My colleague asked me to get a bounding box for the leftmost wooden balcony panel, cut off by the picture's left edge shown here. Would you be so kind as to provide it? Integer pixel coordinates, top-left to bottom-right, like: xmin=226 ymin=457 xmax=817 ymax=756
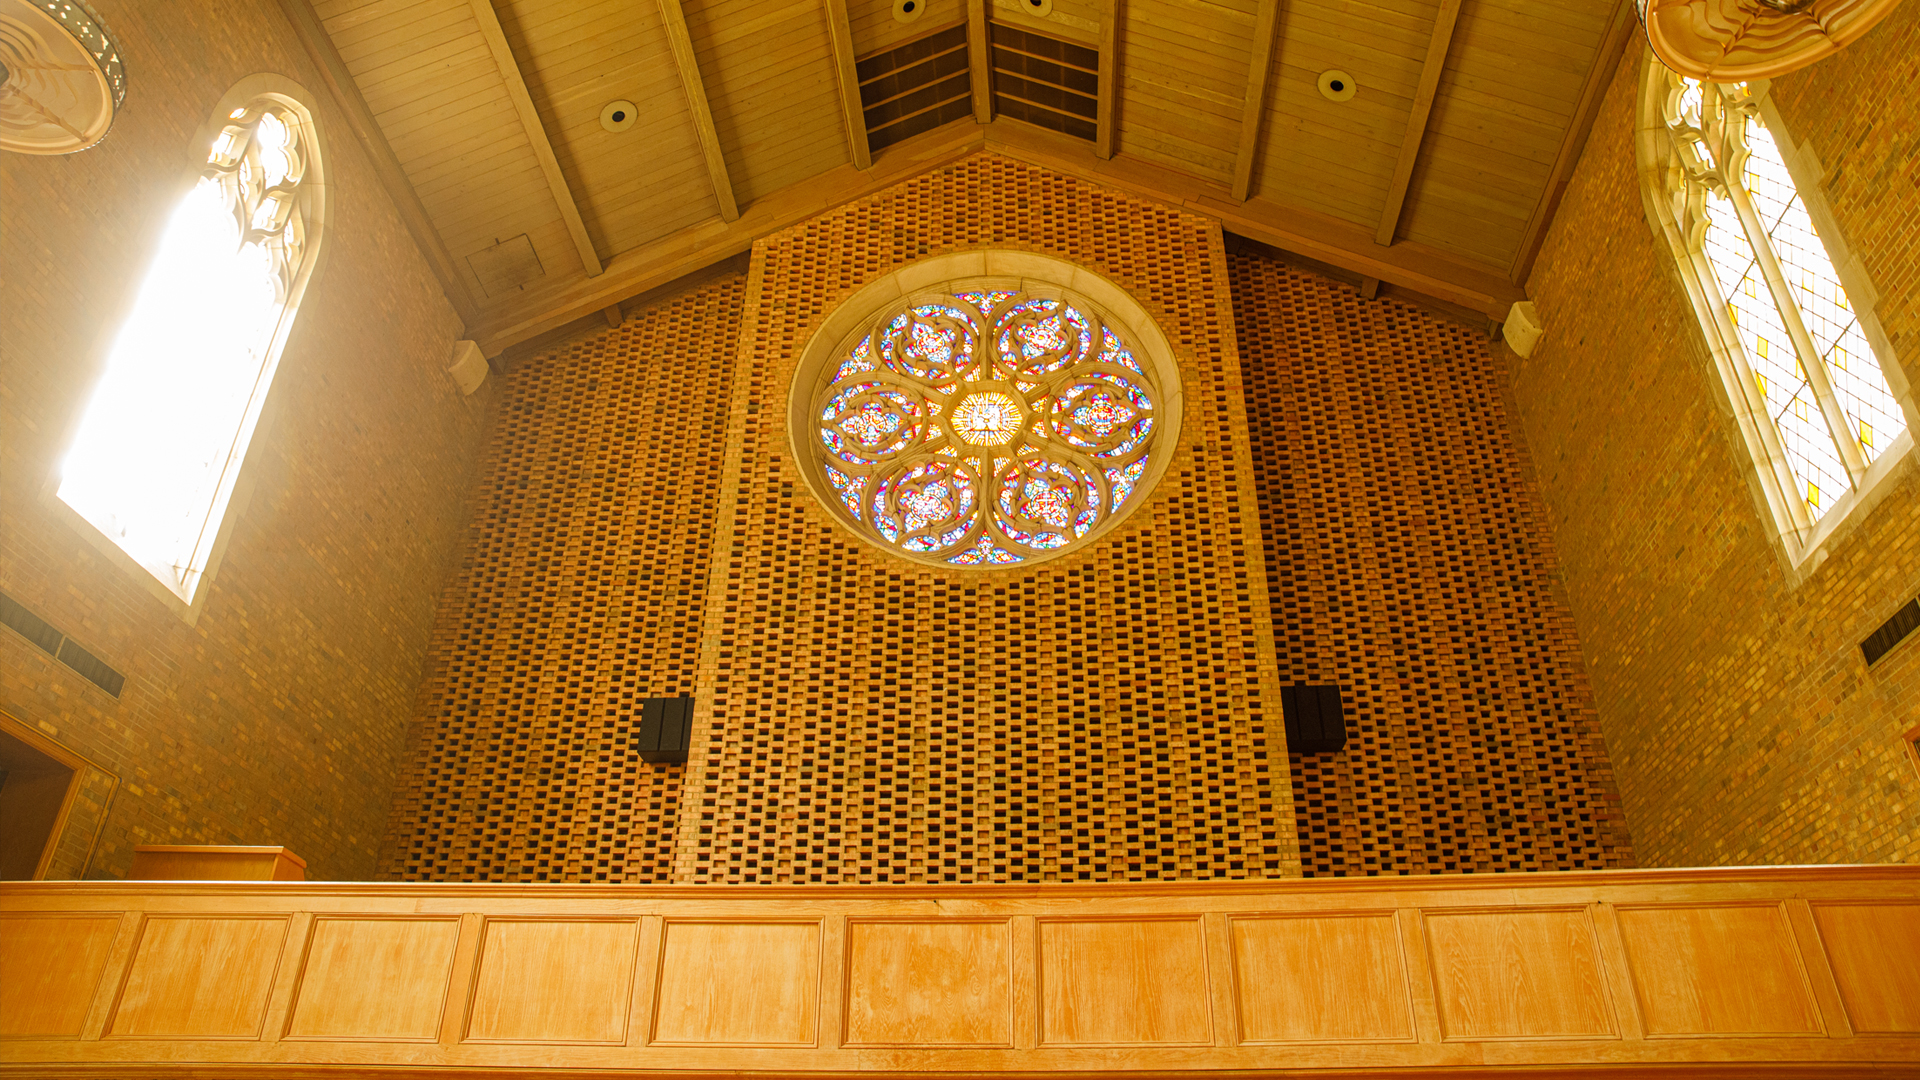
xmin=0 ymin=915 xmax=121 ymax=1038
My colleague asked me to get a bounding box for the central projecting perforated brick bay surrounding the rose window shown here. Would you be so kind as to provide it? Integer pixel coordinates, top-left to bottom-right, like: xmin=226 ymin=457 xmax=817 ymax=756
xmin=676 ymin=154 xmax=1298 ymax=882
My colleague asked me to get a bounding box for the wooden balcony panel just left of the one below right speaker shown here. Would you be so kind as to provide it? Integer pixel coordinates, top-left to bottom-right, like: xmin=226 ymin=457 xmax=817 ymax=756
xmin=1039 ymin=919 xmax=1213 ymax=1045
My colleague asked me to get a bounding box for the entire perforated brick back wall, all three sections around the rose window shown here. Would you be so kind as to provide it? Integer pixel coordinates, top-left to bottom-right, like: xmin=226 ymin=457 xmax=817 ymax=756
xmin=382 ymin=156 xmax=1634 ymax=882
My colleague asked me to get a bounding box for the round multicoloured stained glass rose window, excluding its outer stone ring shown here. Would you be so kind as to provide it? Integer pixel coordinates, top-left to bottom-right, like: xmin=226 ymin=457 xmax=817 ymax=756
xmin=810 ymin=288 xmax=1164 ymax=567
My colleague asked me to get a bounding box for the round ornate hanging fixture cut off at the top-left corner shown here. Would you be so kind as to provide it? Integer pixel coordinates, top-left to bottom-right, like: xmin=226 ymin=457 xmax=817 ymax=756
xmin=0 ymin=0 xmax=127 ymax=154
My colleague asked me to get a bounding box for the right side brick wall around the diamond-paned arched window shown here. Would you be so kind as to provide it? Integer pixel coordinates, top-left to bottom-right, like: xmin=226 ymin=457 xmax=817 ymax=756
xmin=1513 ymin=12 xmax=1920 ymax=865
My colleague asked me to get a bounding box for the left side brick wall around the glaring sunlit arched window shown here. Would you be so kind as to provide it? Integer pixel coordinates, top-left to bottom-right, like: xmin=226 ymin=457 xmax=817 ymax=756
xmin=0 ymin=2 xmax=486 ymax=878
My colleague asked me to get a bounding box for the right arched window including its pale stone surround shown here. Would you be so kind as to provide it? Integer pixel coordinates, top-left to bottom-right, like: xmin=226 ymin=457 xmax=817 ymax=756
xmin=1640 ymin=63 xmax=1912 ymax=563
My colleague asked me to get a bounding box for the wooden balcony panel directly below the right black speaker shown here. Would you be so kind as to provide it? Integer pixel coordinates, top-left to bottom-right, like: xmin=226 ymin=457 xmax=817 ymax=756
xmin=1231 ymin=911 xmax=1413 ymax=1043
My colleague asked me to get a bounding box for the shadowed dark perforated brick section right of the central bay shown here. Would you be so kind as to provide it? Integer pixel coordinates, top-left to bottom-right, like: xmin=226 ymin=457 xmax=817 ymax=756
xmin=1231 ymin=252 xmax=1634 ymax=876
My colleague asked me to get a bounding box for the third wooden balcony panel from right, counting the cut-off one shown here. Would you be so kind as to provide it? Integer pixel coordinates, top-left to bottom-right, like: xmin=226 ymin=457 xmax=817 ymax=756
xmin=1427 ymin=909 xmax=1619 ymax=1040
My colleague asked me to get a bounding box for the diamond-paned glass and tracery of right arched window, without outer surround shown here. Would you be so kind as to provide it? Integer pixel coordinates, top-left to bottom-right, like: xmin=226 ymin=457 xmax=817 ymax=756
xmin=1655 ymin=71 xmax=1907 ymax=528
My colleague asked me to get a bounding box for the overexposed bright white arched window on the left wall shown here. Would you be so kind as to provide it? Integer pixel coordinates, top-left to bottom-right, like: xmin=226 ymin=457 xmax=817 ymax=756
xmin=58 ymin=77 xmax=324 ymax=605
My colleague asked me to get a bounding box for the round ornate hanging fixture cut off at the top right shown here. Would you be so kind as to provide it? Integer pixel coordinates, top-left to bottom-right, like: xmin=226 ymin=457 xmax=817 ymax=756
xmin=1634 ymin=0 xmax=1899 ymax=83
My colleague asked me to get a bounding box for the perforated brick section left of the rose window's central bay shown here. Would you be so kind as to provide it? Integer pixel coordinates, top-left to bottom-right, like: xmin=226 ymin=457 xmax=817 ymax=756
xmin=382 ymin=277 xmax=747 ymax=882
